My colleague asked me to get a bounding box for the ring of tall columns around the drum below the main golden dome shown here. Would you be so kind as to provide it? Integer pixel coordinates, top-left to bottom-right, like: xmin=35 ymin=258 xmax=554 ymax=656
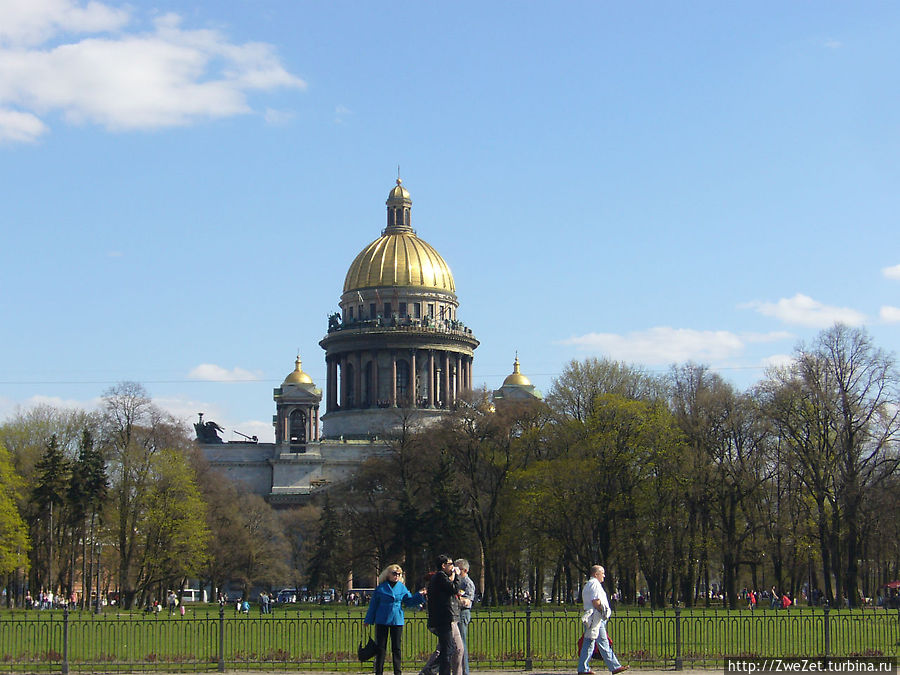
xmin=326 ymin=349 xmax=473 ymax=413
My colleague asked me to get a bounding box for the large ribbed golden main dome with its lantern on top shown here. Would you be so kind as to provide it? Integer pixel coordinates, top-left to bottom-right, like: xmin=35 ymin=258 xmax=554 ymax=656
xmin=344 ymin=178 xmax=456 ymax=293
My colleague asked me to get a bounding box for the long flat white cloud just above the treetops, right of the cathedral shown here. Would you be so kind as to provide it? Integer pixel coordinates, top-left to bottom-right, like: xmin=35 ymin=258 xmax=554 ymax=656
xmin=562 ymin=326 xmax=745 ymax=365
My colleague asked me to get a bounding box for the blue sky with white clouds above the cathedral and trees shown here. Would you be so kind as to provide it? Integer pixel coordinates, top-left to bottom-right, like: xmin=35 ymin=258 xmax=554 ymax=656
xmin=0 ymin=0 xmax=900 ymax=440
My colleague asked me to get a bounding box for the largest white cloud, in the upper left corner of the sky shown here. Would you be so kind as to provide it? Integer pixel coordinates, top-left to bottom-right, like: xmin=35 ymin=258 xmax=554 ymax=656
xmin=0 ymin=0 xmax=306 ymax=140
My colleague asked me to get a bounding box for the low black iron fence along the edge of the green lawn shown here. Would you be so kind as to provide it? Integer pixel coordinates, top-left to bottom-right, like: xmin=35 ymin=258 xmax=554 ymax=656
xmin=0 ymin=607 xmax=900 ymax=675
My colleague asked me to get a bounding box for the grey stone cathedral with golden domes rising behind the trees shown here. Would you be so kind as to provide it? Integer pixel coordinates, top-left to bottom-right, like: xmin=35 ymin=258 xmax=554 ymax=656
xmin=202 ymin=178 xmax=541 ymax=505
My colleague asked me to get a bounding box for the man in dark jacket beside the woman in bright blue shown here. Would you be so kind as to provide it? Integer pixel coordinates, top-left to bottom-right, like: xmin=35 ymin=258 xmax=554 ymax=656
xmin=426 ymin=555 xmax=462 ymax=675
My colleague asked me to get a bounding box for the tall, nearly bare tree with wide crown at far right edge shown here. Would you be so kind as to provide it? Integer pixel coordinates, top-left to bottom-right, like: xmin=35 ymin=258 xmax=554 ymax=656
xmin=762 ymin=324 xmax=900 ymax=606
